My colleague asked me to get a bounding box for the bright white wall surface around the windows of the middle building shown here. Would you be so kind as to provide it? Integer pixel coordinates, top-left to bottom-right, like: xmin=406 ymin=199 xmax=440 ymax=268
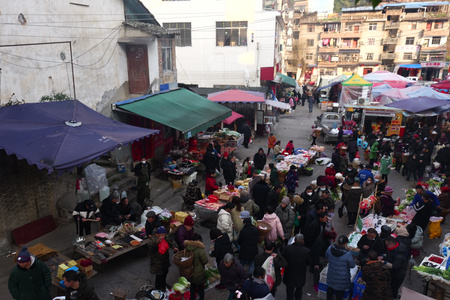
xmin=142 ymin=0 xmax=280 ymax=87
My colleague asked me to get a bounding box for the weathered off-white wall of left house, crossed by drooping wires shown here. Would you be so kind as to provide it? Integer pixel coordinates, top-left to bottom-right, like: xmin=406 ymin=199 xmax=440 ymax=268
xmin=0 ymin=0 xmax=158 ymax=111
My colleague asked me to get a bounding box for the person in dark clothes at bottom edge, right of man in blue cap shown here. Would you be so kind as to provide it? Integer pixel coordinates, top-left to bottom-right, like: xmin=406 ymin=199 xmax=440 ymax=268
xmin=63 ymin=270 xmax=100 ymax=300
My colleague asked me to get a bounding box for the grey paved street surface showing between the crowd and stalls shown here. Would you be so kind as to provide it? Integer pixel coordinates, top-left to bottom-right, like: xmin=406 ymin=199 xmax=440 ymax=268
xmin=0 ymin=102 xmax=449 ymax=300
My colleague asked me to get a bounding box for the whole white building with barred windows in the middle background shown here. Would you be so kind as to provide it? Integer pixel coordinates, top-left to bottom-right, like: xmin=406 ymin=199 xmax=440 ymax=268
xmin=143 ymin=0 xmax=284 ymax=87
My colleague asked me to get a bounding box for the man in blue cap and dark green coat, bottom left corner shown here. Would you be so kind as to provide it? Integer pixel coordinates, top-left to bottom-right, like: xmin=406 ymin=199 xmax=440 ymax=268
xmin=8 ymin=246 xmax=52 ymax=300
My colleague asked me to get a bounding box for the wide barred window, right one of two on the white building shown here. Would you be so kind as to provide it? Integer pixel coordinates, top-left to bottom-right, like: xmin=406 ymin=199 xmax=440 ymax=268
xmin=216 ymin=21 xmax=247 ymax=47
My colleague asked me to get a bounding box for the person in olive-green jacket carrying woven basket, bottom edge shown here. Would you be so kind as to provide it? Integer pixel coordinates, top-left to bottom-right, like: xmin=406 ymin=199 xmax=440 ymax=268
xmin=184 ymin=233 xmax=208 ymax=300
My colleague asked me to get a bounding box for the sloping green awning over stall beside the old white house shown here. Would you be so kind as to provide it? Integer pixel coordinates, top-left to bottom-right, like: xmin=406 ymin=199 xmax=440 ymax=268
xmin=115 ymin=89 xmax=231 ymax=138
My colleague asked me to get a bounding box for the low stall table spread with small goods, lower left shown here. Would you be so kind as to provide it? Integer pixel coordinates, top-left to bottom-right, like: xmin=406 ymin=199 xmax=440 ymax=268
xmin=74 ymin=233 xmax=149 ymax=266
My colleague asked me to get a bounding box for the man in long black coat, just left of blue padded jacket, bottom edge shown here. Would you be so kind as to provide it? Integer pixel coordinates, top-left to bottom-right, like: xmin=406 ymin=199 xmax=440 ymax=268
xmin=283 ymin=233 xmax=311 ymax=300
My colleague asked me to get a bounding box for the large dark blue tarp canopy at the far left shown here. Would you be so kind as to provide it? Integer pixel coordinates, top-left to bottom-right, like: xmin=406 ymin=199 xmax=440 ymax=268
xmin=0 ymin=100 xmax=158 ymax=173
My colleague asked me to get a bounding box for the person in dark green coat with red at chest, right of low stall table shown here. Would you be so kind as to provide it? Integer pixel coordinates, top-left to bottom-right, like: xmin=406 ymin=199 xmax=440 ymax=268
xmin=148 ymin=226 xmax=178 ymax=292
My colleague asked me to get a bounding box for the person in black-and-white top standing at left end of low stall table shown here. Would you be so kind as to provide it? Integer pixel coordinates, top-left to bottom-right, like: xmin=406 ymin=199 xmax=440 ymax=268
xmin=72 ymin=199 xmax=100 ymax=236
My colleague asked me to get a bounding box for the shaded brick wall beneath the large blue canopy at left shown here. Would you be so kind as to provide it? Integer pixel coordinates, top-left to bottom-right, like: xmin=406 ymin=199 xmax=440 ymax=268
xmin=0 ymin=150 xmax=76 ymax=242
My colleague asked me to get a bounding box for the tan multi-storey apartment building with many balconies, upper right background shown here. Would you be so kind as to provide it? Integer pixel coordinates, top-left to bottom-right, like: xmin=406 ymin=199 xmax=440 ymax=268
xmin=286 ymin=2 xmax=450 ymax=81
